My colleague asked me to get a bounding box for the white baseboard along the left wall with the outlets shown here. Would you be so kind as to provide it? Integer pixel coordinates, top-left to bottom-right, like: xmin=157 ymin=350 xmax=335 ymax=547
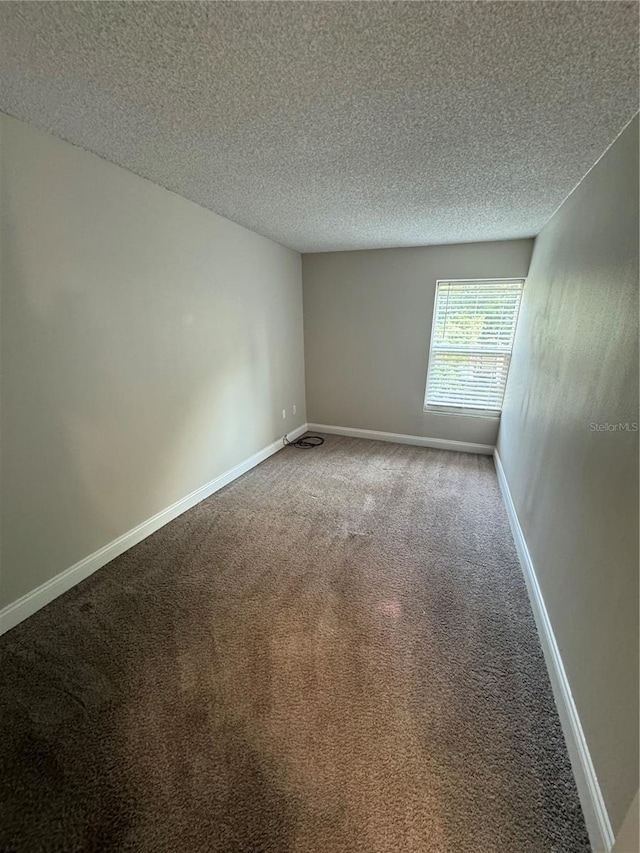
xmin=0 ymin=424 xmax=307 ymax=634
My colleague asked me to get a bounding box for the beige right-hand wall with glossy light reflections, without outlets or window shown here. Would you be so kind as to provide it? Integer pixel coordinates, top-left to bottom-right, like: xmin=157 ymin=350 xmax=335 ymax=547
xmin=498 ymin=119 xmax=639 ymax=832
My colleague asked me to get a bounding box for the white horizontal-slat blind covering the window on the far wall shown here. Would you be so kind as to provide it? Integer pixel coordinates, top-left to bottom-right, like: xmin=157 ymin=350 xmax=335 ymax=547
xmin=425 ymin=280 xmax=524 ymax=412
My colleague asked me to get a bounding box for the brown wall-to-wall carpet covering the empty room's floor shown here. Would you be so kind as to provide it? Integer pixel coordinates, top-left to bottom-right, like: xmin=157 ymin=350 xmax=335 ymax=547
xmin=0 ymin=436 xmax=589 ymax=853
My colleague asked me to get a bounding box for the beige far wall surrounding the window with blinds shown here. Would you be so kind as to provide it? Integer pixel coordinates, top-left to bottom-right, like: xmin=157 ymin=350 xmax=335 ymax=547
xmin=302 ymin=240 xmax=533 ymax=445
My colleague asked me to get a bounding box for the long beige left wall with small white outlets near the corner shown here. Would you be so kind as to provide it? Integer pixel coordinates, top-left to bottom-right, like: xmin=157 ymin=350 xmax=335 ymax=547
xmin=0 ymin=117 xmax=306 ymax=605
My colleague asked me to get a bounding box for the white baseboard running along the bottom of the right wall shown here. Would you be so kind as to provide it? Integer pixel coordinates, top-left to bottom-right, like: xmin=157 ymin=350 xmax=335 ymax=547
xmin=494 ymin=449 xmax=614 ymax=853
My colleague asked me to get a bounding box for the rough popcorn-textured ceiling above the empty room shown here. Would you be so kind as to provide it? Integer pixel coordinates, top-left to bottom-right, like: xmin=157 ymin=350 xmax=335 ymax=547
xmin=0 ymin=0 xmax=638 ymax=252
